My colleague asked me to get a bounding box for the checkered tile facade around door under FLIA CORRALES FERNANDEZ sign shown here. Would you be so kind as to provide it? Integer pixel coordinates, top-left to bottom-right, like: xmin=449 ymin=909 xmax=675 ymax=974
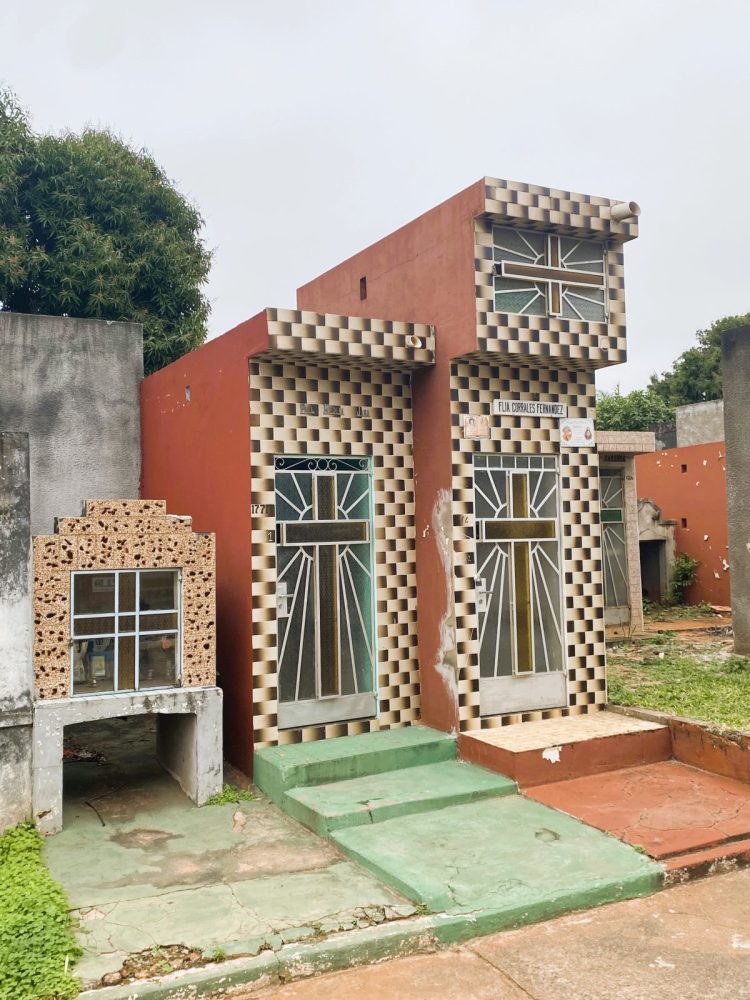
xmin=451 ymin=359 xmax=606 ymax=731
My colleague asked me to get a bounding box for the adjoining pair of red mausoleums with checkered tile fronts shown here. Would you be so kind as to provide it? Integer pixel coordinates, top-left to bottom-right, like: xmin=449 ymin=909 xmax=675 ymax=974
xmin=142 ymin=178 xmax=638 ymax=772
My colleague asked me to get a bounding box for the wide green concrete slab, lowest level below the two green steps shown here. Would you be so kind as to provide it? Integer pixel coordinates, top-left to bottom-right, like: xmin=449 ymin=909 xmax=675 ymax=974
xmin=331 ymin=795 xmax=662 ymax=934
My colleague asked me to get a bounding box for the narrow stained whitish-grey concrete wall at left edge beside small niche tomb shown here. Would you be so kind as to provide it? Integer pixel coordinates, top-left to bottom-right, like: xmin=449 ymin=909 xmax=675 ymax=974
xmin=0 ymin=433 xmax=33 ymax=831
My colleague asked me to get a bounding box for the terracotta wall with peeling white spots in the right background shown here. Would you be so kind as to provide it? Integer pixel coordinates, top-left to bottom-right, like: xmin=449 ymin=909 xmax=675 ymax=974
xmin=635 ymin=441 xmax=730 ymax=606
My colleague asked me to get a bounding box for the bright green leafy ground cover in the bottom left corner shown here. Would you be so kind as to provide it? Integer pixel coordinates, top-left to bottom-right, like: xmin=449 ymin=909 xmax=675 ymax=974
xmin=0 ymin=822 xmax=81 ymax=1000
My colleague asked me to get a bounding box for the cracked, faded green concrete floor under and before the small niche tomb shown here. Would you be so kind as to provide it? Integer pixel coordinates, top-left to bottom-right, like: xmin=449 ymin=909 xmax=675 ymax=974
xmin=44 ymin=719 xmax=415 ymax=984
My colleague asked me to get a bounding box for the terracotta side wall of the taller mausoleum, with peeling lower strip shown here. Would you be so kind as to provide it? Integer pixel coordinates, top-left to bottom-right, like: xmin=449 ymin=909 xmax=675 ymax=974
xmin=297 ymin=179 xmax=485 ymax=731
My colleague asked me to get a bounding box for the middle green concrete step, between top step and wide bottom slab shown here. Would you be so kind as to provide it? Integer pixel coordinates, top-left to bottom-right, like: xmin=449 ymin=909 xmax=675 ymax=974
xmin=283 ymin=760 xmax=517 ymax=837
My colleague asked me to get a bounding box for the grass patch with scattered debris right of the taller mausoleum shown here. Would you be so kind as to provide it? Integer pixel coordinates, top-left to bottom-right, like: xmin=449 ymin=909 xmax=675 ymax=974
xmin=607 ymin=637 xmax=750 ymax=730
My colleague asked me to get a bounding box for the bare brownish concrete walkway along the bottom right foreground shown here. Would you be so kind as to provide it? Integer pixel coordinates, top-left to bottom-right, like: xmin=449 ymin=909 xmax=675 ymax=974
xmin=238 ymin=870 xmax=750 ymax=1000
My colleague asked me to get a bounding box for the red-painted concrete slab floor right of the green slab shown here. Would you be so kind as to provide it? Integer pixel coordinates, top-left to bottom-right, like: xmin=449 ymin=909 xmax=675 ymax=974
xmin=525 ymin=761 xmax=750 ymax=860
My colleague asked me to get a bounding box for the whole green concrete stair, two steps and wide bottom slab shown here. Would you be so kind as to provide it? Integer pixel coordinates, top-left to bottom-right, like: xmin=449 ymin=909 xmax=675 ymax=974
xmin=255 ymin=726 xmax=663 ymax=924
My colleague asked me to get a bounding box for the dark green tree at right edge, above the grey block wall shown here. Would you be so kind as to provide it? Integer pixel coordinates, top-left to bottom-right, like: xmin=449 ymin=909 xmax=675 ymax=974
xmin=648 ymin=313 xmax=750 ymax=406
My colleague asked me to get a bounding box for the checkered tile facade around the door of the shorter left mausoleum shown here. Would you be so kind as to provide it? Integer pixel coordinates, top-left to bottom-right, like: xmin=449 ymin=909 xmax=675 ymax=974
xmin=249 ymin=359 xmax=420 ymax=747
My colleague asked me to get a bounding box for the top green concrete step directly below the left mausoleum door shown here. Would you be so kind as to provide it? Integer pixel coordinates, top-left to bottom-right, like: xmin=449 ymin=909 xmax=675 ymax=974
xmin=253 ymin=726 xmax=456 ymax=805
